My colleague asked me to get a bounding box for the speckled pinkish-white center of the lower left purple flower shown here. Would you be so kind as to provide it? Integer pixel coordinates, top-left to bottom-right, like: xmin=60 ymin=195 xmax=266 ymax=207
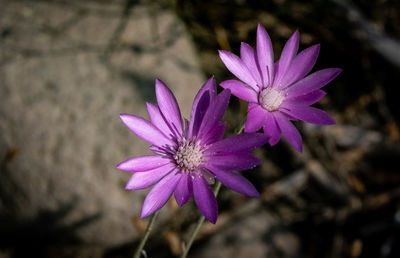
xmin=174 ymin=139 xmax=203 ymax=172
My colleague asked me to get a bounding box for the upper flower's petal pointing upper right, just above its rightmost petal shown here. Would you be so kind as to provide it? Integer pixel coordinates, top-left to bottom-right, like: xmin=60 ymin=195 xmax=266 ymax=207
xmin=280 ymin=44 xmax=320 ymax=87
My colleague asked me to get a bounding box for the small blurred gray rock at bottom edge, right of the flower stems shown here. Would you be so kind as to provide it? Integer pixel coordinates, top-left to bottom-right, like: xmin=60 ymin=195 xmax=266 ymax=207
xmin=191 ymin=210 xmax=300 ymax=258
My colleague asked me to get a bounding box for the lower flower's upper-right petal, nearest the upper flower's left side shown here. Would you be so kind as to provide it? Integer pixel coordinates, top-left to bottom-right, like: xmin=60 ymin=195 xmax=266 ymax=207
xmin=197 ymin=89 xmax=231 ymax=139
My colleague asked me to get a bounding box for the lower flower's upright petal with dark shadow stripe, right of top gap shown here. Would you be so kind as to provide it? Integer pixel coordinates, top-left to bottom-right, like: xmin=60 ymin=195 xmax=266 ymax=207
xmin=188 ymin=77 xmax=217 ymax=139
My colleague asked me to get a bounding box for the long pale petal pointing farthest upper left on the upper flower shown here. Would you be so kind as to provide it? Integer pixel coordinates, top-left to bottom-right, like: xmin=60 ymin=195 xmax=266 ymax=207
xmin=219 ymin=50 xmax=257 ymax=88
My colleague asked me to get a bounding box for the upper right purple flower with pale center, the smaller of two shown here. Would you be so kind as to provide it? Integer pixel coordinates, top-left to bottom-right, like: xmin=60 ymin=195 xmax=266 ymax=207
xmin=219 ymin=25 xmax=342 ymax=151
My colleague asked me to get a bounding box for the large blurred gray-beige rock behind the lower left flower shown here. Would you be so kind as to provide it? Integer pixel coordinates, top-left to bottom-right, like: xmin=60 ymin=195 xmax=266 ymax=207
xmin=0 ymin=1 xmax=205 ymax=250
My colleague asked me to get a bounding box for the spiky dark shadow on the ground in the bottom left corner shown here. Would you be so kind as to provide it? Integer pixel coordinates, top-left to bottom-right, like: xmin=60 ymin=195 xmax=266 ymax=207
xmin=0 ymin=202 xmax=100 ymax=258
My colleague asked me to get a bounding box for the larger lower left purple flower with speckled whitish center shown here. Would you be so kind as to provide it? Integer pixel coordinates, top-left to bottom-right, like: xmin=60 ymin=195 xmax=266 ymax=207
xmin=117 ymin=78 xmax=268 ymax=223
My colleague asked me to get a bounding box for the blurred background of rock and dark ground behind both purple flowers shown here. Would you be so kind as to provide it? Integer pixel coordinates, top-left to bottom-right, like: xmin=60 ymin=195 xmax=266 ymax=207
xmin=0 ymin=0 xmax=400 ymax=258
